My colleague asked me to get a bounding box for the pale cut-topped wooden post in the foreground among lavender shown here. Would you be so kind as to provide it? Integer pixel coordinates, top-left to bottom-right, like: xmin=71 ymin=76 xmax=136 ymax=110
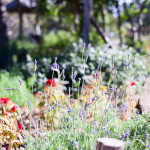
xmin=96 ymin=138 xmax=124 ymax=150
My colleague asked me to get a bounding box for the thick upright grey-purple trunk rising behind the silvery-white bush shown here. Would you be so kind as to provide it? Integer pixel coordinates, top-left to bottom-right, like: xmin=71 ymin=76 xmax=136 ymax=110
xmin=83 ymin=0 xmax=93 ymax=45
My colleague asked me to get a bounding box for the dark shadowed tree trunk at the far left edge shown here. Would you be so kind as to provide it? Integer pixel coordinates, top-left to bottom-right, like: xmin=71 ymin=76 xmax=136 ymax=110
xmin=0 ymin=0 xmax=8 ymax=45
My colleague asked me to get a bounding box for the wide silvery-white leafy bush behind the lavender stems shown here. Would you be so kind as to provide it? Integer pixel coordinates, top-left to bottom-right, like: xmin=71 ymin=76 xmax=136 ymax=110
xmin=24 ymin=41 xmax=149 ymax=89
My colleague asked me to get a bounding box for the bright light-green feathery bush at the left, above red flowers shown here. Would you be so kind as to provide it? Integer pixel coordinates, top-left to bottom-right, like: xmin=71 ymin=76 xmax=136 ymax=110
xmin=0 ymin=72 xmax=34 ymax=106
